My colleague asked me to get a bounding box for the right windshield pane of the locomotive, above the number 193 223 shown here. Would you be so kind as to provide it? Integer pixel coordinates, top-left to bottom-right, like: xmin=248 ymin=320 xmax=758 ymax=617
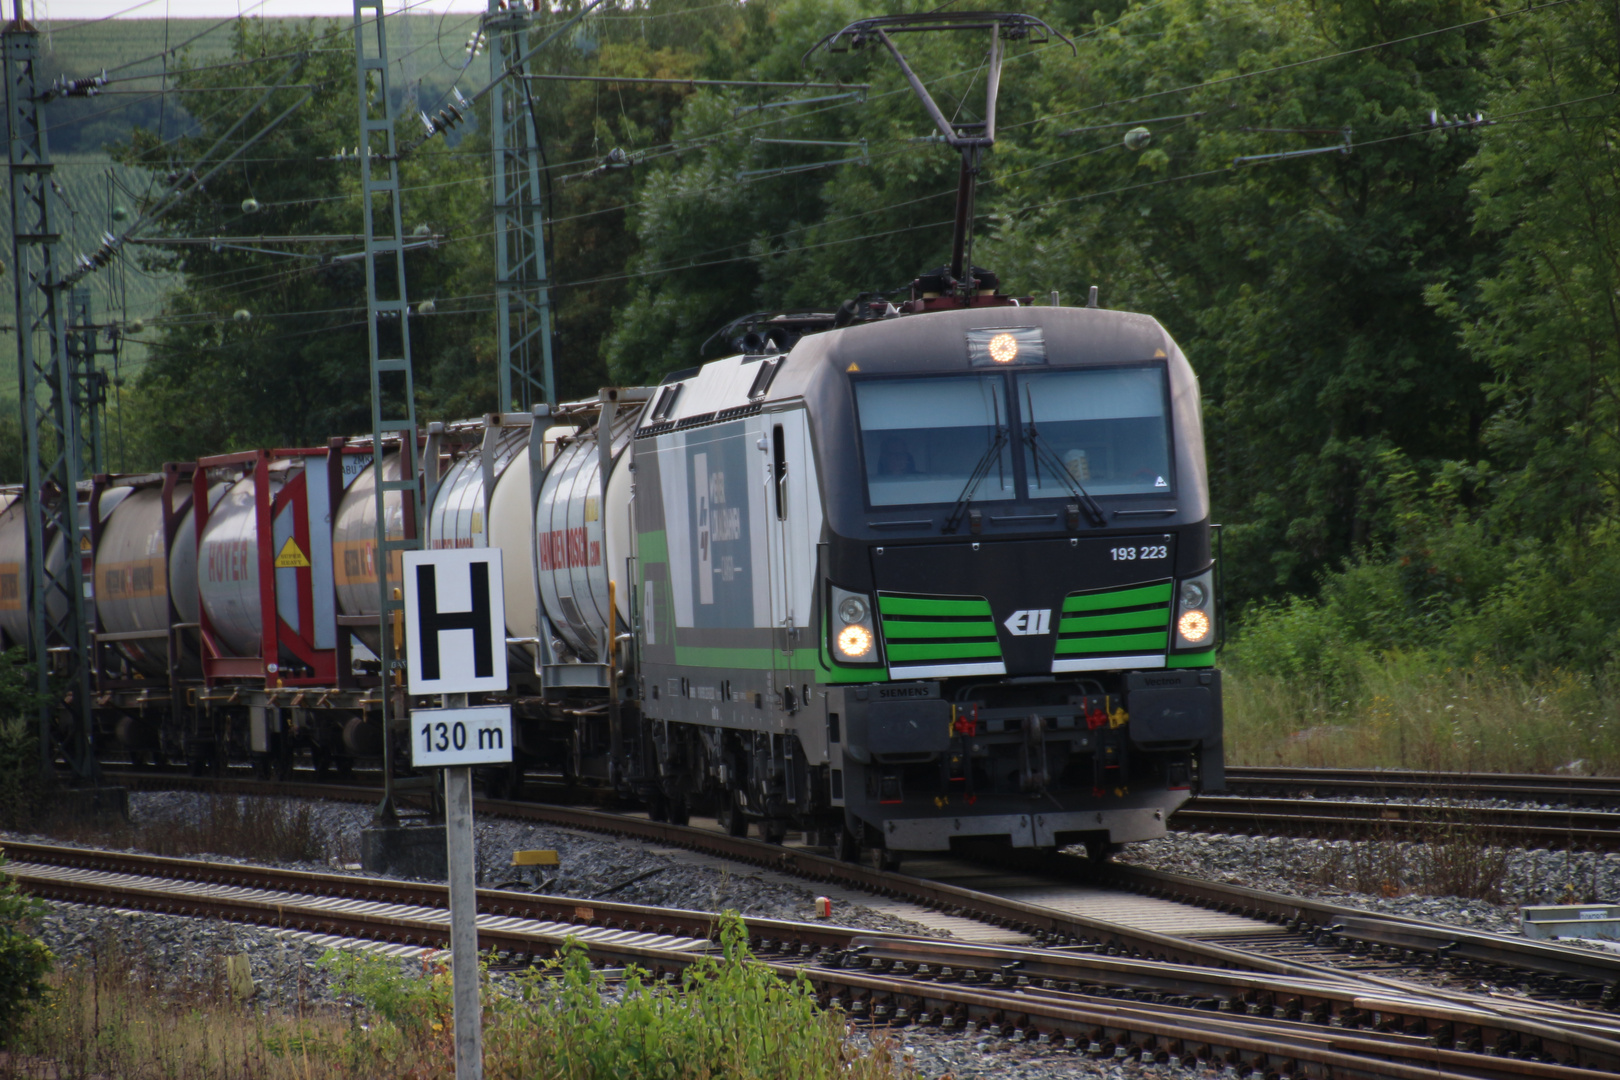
xmin=1016 ymin=366 xmax=1173 ymax=499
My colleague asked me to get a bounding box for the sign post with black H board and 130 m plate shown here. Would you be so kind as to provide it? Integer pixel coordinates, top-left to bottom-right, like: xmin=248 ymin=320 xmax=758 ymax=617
xmin=403 ymin=547 xmax=512 ymax=1080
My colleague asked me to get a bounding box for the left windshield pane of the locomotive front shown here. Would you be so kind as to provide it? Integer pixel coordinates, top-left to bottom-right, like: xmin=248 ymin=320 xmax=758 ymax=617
xmin=855 ymin=376 xmax=1016 ymax=507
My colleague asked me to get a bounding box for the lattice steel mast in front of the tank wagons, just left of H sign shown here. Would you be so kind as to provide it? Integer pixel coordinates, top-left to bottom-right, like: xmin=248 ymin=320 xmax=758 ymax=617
xmin=355 ymin=0 xmax=423 ymax=823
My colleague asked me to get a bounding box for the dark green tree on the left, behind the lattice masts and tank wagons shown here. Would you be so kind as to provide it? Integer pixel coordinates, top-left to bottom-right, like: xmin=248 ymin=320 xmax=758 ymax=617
xmin=120 ymin=19 xmax=494 ymax=465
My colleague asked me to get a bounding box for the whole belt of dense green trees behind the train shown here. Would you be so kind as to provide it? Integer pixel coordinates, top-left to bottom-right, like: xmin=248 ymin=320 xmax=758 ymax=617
xmin=41 ymin=0 xmax=1620 ymax=682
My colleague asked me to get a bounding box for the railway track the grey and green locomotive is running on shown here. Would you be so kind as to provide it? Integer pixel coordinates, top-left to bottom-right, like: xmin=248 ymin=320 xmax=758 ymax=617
xmin=98 ymin=774 xmax=1620 ymax=1009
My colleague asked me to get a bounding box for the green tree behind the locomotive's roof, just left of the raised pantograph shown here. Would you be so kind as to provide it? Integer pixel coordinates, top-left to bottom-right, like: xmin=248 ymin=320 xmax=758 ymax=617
xmin=604 ymin=0 xmax=983 ymax=382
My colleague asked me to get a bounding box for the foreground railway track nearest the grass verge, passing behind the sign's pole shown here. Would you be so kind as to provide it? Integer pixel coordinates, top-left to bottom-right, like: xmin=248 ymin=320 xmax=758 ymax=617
xmin=6 ymin=844 xmax=1620 ymax=1080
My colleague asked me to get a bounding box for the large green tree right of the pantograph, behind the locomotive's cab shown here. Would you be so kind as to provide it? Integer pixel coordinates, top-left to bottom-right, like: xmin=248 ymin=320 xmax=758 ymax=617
xmin=987 ymin=0 xmax=1494 ymax=599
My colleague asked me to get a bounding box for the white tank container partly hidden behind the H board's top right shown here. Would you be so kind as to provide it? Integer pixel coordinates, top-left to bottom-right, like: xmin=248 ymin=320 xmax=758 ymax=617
xmin=428 ymin=427 xmax=539 ymax=650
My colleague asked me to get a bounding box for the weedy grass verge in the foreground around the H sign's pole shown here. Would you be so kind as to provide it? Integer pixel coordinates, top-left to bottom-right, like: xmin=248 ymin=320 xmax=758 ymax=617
xmin=0 ymin=916 xmax=910 ymax=1080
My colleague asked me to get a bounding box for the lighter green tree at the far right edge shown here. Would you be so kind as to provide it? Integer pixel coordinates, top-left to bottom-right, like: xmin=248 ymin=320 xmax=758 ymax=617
xmin=1430 ymin=5 xmax=1620 ymax=538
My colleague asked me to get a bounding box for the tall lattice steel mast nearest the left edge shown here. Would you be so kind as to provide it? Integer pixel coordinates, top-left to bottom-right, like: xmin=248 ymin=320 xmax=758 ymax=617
xmin=0 ymin=0 xmax=97 ymax=777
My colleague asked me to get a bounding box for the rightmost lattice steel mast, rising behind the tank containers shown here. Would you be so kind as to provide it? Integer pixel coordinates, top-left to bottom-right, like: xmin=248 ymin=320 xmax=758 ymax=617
xmin=483 ymin=0 xmax=557 ymax=413
